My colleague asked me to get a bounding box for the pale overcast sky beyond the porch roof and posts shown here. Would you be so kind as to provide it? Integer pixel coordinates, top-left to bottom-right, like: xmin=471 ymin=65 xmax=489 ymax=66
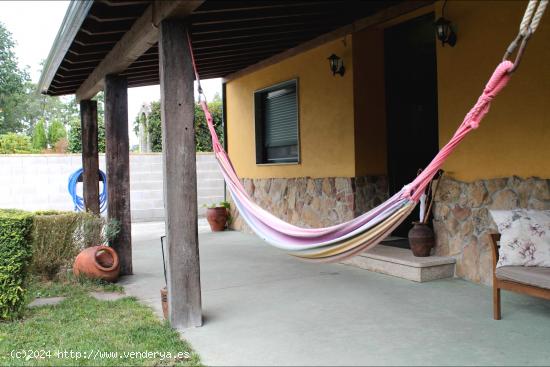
xmin=0 ymin=0 xmax=222 ymax=145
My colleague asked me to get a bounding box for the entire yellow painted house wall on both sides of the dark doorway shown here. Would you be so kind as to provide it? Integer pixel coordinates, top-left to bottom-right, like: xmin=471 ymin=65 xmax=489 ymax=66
xmin=227 ymin=1 xmax=550 ymax=181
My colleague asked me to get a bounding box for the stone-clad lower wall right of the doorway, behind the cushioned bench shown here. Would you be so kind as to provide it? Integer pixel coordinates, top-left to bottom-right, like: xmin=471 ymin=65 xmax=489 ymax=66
xmin=433 ymin=176 xmax=550 ymax=285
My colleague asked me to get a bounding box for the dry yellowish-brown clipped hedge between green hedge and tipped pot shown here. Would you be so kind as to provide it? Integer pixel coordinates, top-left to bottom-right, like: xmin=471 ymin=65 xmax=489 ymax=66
xmin=30 ymin=211 xmax=81 ymax=279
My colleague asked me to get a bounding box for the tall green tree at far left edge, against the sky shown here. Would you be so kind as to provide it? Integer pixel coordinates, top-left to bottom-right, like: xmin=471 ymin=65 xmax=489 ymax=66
xmin=0 ymin=23 xmax=30 ymax=134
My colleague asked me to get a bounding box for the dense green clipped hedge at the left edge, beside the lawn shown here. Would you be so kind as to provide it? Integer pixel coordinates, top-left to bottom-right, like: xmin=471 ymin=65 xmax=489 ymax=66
xmin=0 ymin=209 xmax=32 ymax=319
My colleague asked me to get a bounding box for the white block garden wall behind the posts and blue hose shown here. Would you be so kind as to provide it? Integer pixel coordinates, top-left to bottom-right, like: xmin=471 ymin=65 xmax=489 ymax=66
xmin=0 ymin=153 xmax=224 ymax=221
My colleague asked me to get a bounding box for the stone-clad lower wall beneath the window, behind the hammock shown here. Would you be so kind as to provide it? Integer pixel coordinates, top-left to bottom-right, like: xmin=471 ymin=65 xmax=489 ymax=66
xmin=228 ymin=176 xmax=388 ymax=233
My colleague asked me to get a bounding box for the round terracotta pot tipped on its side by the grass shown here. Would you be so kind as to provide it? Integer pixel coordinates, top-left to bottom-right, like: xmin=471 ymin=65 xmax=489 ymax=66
xmin=73 ymin=246 xmax=120 ymax=282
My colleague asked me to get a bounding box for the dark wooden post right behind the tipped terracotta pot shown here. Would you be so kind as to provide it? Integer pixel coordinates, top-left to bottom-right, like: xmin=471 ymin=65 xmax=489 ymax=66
xmin=105 ymin=75 xmax=132 ymax=275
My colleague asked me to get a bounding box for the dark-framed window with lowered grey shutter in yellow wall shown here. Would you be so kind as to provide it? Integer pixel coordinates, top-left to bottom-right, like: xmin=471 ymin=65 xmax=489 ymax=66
xmin=254 ymin=80 xmax=299 ymax=164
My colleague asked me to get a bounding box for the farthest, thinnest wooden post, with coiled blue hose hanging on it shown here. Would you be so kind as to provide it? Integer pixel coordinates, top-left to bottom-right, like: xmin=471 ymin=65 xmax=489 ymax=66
xmin=80 ymin=100 xmax=99 ymax=215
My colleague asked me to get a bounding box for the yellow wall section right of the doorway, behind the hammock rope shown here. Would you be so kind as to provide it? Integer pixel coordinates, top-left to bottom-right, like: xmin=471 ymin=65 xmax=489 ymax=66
xmin=437 ymin=1 xmax=550 ymax=181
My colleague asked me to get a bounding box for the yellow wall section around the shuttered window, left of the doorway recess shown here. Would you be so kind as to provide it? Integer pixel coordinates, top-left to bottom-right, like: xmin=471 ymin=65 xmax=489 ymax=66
xmin=226 ymin=37 xmax=355 ymax=178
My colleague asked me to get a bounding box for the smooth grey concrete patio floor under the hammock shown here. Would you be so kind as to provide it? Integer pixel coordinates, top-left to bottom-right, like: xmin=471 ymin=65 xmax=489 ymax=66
xmin=122 ymin=223 xmax=550 ymax=365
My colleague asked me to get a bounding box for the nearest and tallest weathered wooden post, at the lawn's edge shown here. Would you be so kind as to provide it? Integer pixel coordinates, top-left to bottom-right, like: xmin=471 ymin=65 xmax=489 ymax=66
xmin=159 ymin=19 xmax=202 ymax=328
